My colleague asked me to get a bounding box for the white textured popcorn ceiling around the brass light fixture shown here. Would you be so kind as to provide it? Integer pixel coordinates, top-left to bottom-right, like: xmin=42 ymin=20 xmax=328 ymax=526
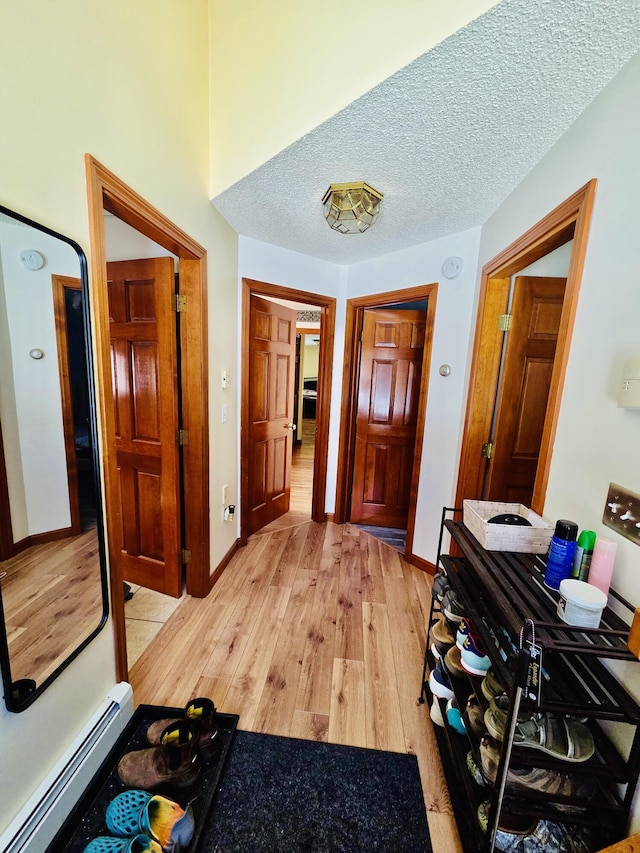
xmin=213 ymin=0 xmax=640 ymax=264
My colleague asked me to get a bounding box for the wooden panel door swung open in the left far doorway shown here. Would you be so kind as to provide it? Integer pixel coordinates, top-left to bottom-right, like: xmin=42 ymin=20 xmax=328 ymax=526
xmin=247 ymin=296 xmax=296 ymax=534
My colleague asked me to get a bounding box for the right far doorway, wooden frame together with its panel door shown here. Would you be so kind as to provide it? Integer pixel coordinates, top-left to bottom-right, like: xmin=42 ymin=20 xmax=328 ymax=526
xmin=335 ymin=284 xmax=438 ymax=562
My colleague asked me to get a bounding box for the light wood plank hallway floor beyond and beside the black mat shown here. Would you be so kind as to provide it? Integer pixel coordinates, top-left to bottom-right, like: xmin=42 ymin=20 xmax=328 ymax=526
xmin=129 ymin=519 xmax=461 ymax=853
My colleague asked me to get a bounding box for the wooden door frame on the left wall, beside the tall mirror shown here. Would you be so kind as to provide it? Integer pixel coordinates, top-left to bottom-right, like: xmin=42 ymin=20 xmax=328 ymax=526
xmin=85 ymin=154 xmax=211 ymax=680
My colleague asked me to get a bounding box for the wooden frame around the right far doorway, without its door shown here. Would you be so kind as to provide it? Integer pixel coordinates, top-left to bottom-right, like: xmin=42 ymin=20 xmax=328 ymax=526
xmin=334 ymin=283 xmax=438 ymax=562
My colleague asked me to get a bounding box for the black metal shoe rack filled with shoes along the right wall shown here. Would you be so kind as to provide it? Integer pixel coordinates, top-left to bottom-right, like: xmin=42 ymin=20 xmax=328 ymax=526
xmin=420 ymin=507 xmax=640 ymax=853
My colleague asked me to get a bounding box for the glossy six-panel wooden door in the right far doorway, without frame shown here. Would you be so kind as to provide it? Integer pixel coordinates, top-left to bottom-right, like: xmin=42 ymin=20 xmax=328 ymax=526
xmin=350 ymin=308 xmax=426 ymax=527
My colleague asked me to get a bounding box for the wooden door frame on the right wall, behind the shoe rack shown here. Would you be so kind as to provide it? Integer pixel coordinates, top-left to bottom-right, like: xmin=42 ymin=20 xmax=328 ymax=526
xmin=456 ymin=179 xmax=597 ymax=513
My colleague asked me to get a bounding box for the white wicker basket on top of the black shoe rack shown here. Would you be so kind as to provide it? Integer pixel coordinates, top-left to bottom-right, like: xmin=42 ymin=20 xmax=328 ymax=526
xmin=462 ymin=500 xmax=554 ymax=554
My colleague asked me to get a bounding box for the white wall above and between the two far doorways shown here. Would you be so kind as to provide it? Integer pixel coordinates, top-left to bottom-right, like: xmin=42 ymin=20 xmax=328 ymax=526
xmin=239 ymin=228 xmax=480 ymax=562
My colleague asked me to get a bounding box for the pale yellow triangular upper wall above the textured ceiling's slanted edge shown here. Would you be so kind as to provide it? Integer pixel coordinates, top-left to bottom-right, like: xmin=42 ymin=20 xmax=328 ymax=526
xmin=210 ymin=0 xmax=499 ymax=196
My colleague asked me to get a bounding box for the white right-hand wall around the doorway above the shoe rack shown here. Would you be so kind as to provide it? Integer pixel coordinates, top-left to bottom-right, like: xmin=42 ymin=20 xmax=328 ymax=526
xmin=480 ymin=48 xmax=640 ymax=831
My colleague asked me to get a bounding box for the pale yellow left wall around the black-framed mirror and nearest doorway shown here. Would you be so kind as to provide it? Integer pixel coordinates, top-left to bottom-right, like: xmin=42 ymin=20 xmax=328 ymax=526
xmin=0 ymin=0 xmax=238 ymax=831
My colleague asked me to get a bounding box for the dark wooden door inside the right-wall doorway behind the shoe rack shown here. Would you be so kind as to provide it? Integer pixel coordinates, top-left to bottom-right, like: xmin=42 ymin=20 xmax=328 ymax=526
xmin=485 ymin=276 xmax=567 ymax=506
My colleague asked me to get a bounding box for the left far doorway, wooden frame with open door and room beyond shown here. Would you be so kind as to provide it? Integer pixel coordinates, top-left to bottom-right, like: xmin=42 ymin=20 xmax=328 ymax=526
xmin=241 ymin=279 xmax=335 ymax=541
